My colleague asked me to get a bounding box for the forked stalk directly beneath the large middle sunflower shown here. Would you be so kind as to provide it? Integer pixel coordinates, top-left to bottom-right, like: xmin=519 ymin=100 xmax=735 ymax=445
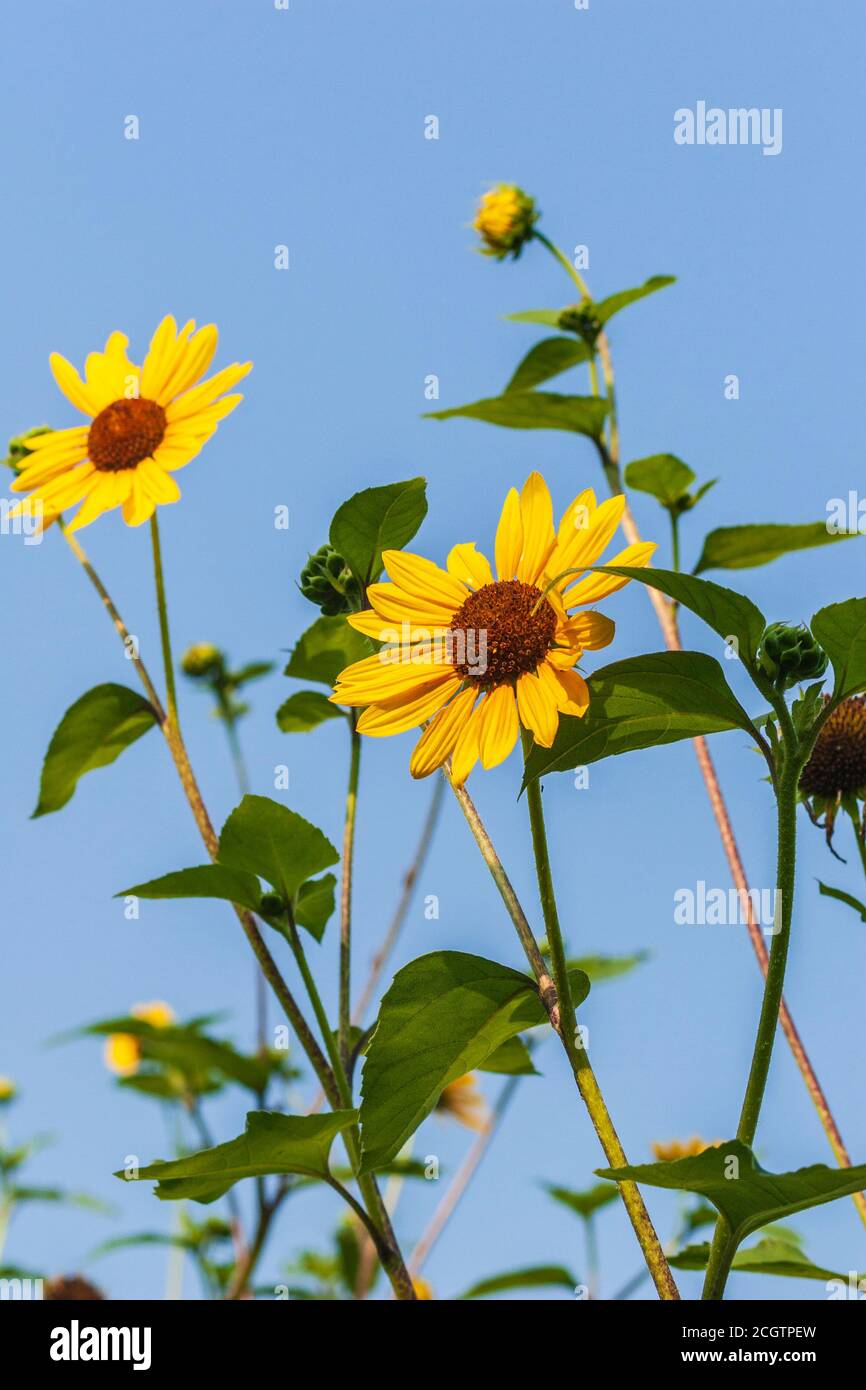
xmin=446 ymin=765 xmax=680 ymax=1300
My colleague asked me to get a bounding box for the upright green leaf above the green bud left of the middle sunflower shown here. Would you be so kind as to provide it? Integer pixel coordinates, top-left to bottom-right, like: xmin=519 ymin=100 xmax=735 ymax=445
xmin=329 ymin=478 xmax=427 ymax=584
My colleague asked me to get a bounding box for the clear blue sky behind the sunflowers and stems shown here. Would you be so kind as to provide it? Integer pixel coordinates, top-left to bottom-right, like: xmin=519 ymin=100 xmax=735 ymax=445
xmin=0 ymin=0 xmax=866 ymax=1298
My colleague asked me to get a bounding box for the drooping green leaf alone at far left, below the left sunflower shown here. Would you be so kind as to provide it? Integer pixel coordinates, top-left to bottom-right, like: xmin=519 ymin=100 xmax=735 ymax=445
xmin=33 ymin=685 xmax=157 ymax=819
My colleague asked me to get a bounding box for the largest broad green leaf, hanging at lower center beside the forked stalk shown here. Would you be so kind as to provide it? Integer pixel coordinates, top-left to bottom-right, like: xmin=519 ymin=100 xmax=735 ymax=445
xmin=361 ymin=951 xmax=589 ymax=1173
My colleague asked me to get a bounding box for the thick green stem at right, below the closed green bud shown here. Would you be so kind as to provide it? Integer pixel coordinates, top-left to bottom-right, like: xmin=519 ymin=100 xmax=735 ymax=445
xmin=702 ymin=745 xmax=803 ymax=1300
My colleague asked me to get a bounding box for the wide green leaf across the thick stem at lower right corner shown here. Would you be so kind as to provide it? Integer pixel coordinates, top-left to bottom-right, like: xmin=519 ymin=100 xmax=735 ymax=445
xmin=596 ymin=1138 xmax=866 ymax=1245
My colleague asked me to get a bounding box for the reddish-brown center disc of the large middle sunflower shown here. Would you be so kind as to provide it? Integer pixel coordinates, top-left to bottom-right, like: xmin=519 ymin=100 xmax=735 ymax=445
xmin=450 ymin=580 xmax=556 ymax=689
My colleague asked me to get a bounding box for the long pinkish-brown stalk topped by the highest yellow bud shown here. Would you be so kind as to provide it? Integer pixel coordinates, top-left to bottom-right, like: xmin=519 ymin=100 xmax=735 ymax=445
xmin=535 ymin=232 xmax=866 ymax=1226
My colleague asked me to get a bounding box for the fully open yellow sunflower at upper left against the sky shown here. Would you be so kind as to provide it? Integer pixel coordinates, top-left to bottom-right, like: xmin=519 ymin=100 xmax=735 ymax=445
xmin=10 ymin=314 xmax=252 ymax=531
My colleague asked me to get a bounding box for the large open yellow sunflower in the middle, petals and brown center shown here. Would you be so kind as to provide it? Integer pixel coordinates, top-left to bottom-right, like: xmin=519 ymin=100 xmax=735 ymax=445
xmin=331 ymin=473 xmax=655 ymax=785
